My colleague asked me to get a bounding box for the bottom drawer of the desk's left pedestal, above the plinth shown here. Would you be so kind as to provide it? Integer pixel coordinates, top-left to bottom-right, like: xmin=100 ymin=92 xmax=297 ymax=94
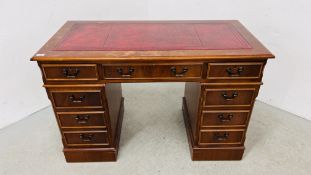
xmin=63 ymin=130 xmax=109 ymax=146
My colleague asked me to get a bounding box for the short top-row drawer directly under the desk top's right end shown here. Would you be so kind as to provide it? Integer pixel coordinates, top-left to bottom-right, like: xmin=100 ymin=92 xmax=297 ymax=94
xmin=207 ymin=62 xmax=264 ymax=79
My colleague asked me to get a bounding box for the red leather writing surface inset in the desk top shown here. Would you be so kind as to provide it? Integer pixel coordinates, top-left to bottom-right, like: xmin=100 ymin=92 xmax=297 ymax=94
xmin=53 ymin=22 xmax=252 ymax=51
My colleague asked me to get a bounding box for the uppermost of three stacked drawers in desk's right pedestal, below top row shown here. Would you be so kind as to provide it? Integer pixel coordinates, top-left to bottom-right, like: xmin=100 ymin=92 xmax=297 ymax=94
xmin=204 ymin=88 xmax=257 ymax=107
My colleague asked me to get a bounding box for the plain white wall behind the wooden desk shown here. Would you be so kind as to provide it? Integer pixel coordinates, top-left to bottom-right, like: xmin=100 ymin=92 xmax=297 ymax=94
xmin=0 ymin=0 xmax=311 ymax=128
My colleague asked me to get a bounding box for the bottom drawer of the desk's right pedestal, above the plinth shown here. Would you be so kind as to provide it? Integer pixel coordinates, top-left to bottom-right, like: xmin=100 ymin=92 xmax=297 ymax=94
xmin=199 ymin=129 xmax=245 ymax=145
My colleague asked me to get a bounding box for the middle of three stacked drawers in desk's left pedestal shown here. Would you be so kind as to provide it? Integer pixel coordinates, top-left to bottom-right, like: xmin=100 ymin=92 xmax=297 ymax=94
xmin=57 ymin=111 xmax=106 ymax=128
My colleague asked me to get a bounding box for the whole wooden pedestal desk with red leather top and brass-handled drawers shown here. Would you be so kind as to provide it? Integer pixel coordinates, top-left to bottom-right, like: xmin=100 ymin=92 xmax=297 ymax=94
xmin=32 ymin=20 xmax=274 ymax=162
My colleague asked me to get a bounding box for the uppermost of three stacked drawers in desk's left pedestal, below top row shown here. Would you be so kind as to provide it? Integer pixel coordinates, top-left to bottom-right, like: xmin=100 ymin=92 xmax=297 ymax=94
xmin=50 ymin=90 xmax=103 ymax=108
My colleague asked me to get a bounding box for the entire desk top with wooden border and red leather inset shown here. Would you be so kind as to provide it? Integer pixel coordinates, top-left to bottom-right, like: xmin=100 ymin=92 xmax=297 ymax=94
xmin=32 ymin=20 xmax=274 ymax=61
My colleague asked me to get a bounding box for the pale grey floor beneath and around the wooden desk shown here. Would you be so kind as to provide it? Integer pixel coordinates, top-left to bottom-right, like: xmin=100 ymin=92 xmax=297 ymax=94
xmin=0 ymin=83 xmax=311 ymax=175
